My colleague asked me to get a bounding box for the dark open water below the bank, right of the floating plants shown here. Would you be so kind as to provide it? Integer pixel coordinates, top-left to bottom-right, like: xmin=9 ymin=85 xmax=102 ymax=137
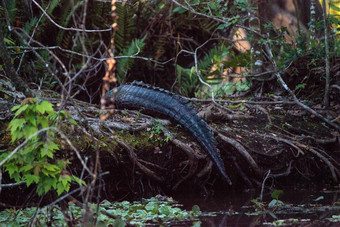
xmin=174 ymin=188 xmax=340 ymax=226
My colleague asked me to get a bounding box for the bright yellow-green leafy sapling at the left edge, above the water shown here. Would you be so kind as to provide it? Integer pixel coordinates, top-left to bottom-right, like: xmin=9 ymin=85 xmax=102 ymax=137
xmin=0 ymin=98 xmax=83 ymax=195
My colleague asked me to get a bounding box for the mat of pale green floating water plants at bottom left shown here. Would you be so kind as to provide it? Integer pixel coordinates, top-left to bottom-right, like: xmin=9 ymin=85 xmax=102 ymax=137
xmin=0 ymin=197 xmax=201 ymax=226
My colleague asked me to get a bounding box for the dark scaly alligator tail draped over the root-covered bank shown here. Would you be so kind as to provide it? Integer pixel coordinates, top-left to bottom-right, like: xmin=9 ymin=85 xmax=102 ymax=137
xmin=106 ymin=81 xmax=232 ymax=185
